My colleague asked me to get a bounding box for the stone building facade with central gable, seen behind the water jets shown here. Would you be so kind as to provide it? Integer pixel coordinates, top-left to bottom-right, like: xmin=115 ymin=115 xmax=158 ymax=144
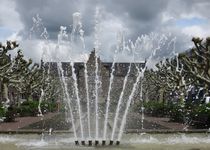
xmin=48 ymin=51 xmax=145 ymax=110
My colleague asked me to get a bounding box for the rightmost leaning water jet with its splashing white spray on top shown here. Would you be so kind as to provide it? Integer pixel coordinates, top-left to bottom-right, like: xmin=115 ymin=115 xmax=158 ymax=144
xmin=111 ymin=33 xmax=176 ymax=137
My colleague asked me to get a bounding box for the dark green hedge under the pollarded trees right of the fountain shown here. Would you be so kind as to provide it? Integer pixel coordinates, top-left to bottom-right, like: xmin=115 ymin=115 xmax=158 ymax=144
xmin=133 ymin=101 xmax=210 ymax=128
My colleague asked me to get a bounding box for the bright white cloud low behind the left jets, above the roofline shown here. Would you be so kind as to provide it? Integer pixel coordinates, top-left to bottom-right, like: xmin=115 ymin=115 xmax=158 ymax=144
xmin=20 ymin=40 xmax=92 ymax=63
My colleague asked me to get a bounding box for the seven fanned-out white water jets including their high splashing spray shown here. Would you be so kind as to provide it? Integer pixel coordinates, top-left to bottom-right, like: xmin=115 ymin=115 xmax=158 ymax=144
xmin=25 ymin=8 xmax=182 ymax=146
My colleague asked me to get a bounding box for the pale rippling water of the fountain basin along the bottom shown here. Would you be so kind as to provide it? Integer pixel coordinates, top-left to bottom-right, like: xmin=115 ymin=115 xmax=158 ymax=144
xmin=0 ymin=133 xmax=210 ymax=150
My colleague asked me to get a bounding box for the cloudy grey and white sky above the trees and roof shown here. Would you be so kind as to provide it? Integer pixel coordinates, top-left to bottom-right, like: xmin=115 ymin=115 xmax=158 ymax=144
xmin=0 ymin=0 xmax=210 ymax=61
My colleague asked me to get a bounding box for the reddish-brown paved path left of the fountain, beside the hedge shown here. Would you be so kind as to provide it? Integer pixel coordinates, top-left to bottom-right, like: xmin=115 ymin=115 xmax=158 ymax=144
xmin=0 ymin=113 xmax=58 ymax=131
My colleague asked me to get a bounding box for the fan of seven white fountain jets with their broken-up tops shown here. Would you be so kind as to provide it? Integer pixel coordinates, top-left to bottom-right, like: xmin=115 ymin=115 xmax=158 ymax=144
xmin=26 ymin=8 xmax=178 ymax=146
